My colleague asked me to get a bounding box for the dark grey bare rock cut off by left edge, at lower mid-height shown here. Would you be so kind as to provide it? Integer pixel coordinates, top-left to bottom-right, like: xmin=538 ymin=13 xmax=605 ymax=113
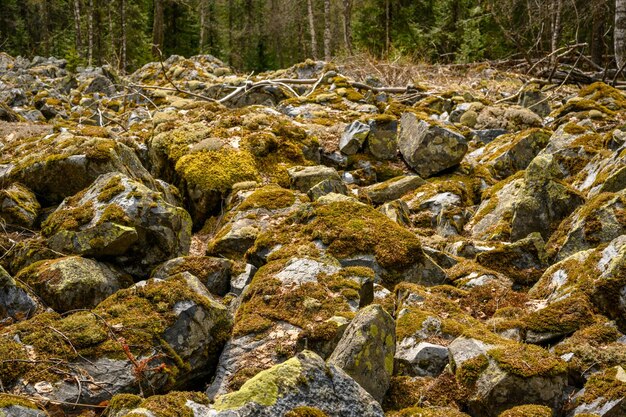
xmin=0 ymin=266 xmax=39 ymax=323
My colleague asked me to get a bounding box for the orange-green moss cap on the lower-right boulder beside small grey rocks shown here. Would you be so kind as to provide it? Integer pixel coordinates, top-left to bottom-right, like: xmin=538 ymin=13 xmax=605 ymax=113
xmin=488 ymin=344 xmax=567 ymax=378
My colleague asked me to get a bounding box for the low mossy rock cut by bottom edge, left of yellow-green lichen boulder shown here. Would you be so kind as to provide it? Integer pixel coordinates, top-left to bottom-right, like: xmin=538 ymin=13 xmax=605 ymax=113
xmin=103 ymin=391 xmax=210 ymax=417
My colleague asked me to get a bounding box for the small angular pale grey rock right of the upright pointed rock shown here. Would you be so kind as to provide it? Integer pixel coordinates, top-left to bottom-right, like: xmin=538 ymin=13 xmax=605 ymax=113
xmin=395 ymin=338 xmax=449 ymax=377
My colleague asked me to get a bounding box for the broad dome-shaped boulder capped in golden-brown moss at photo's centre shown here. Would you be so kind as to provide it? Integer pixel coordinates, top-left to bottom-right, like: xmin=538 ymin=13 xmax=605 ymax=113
xmin=248 ymin=200 xmax=447 ymax=287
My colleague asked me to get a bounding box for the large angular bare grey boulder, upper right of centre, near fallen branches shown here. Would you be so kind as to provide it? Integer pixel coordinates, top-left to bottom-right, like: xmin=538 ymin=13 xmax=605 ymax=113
xmin=398 ymin=113 xmax=468 ymax=178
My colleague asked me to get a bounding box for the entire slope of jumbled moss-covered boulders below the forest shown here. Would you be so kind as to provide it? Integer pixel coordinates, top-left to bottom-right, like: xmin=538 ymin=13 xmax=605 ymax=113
xmin=0 ymin=54 xmax=626 ymax=417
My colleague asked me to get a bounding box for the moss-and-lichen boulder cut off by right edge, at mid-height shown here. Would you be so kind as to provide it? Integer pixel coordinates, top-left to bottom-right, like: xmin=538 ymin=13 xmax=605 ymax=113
xmin=548 ymin=190 xmax=626 ymax=260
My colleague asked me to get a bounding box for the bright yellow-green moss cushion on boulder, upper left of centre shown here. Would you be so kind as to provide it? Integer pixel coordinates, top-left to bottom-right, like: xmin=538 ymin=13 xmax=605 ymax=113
xmin=176 ymin=148 xmax=260 ymax=193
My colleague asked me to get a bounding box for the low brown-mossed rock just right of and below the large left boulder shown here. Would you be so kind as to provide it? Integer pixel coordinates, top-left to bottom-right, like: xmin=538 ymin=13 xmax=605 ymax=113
xmin=151 ymin=256 xmax=233 ymax=296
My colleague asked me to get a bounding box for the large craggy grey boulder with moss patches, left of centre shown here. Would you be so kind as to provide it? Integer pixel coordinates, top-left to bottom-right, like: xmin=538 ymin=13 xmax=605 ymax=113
xmin=42 ymin=173 xmax=191 ymax=278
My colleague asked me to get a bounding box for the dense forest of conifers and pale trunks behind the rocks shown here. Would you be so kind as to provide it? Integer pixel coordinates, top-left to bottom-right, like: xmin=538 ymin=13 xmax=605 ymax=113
xmin=0 ymin=0 xmax=619 ymax=71
